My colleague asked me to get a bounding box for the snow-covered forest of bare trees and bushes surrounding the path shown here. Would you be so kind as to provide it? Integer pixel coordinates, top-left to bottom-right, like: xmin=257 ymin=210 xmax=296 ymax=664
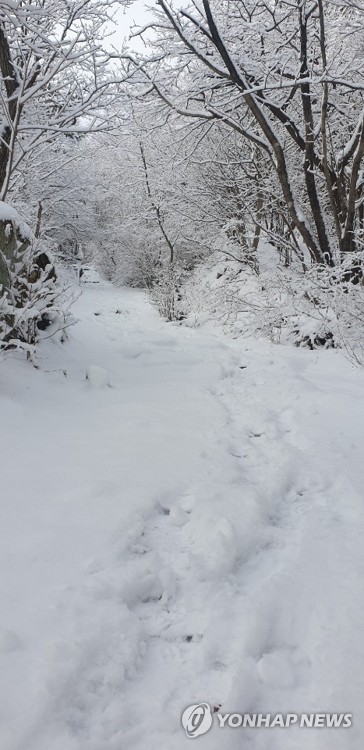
xmin=0 ymin=0 xmax=364 ymax=364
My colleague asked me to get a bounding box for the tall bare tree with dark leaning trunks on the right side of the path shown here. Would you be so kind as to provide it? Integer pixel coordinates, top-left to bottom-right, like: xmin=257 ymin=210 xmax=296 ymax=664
xmin=124 ymin=0 xmax=364 ymax=280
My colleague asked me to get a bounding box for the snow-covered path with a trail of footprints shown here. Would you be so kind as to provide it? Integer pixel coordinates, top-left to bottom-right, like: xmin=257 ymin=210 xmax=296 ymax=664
xmin=0 ymin=282 xmax=364 ymax=750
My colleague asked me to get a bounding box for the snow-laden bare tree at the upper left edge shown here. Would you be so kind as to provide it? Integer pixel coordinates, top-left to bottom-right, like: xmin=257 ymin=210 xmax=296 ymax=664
xmin=0 ymin=0 xmax=127 ymax=200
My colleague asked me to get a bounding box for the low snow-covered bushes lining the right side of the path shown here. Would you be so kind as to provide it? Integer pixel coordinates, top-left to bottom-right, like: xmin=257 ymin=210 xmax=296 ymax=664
xmin=180 ymin=247 xmax=364 ymax=364
